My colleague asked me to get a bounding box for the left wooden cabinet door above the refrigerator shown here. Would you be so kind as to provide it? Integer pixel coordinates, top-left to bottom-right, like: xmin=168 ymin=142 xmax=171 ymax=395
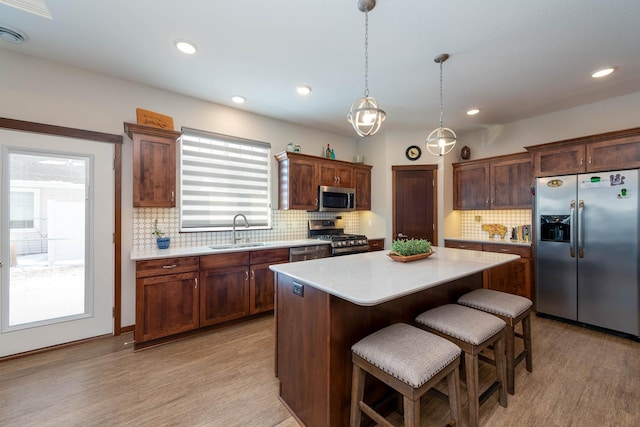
xmin=532 ymin=144 xmax=586 ymax=177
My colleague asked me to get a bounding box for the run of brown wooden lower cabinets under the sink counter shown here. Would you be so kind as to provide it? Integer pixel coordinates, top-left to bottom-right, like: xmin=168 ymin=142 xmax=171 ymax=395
xmin=135 ymin=248 xmax=289 ymax=347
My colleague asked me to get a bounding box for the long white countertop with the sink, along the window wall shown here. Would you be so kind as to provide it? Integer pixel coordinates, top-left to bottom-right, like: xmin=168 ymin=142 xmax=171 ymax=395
xmin=131 ymin=239 xmax=330 ymax=261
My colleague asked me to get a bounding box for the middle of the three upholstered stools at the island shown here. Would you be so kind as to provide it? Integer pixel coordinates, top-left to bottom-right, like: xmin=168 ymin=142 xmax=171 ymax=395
xmin=416 ymin=304 xmax=507 ymax=427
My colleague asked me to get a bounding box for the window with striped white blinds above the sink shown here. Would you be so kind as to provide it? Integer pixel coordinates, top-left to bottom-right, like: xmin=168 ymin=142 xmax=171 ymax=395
xmin=180 ymin=128 xmax=271 ymax=231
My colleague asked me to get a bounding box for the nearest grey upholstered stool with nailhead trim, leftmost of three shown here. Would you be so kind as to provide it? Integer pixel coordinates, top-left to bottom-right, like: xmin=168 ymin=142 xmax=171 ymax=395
xmin=351 ymin=323 xmax=461 ymax=427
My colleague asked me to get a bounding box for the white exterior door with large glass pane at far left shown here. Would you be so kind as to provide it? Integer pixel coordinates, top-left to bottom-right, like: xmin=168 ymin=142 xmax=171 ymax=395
xmin=0 ymin=130 xmax=114 ymax=357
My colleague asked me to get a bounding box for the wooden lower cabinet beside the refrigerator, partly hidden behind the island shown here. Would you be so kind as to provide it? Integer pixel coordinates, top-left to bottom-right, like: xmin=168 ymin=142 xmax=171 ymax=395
xmin=445 ymin=240 xmax=533 ymax=300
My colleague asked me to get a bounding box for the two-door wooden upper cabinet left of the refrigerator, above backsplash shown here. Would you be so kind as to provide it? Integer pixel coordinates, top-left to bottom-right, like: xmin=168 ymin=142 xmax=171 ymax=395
xmin=453 ymin=153 xmax=532 ymax=210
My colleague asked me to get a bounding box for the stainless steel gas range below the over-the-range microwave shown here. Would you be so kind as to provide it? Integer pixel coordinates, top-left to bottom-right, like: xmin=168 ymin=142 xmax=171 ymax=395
xmin=309 ymin=218 xmax=369 ymax=256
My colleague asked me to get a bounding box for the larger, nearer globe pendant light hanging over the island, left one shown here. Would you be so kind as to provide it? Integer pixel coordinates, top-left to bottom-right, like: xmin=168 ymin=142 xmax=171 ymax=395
xmin=347 ymin=0 xmax=387 ymax=137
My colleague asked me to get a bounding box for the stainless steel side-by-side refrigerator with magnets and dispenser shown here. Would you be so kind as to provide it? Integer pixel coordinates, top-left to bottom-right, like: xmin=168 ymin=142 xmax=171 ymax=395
xmin=534 ymin=169 xmax=640 ymax=337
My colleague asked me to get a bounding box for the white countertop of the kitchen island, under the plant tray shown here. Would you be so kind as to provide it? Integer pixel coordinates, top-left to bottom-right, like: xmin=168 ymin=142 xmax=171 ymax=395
xmin=269 ymin=246 xmax=520 ymax=306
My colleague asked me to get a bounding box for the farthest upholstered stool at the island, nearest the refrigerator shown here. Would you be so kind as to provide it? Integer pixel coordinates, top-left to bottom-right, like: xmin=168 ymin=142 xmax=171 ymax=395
xmin=458 ymin=289 xmax=533 ymax=394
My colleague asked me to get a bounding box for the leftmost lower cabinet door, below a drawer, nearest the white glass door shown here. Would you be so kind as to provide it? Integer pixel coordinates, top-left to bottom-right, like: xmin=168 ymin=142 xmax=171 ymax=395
xmin=135 ymin=272 xmax=199 ymax=343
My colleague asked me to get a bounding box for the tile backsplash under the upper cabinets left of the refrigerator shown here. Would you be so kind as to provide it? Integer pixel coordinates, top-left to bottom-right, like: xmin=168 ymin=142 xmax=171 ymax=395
xmin=460 ymin=209 xmax=531 ymax=239
